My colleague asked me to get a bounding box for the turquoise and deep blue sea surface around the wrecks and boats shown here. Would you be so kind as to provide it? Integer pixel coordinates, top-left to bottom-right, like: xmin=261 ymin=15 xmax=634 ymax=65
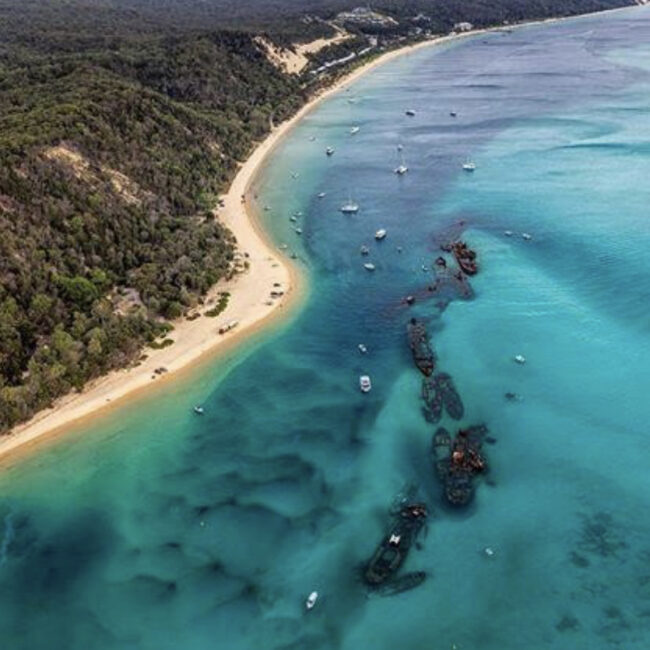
xmin=0 ymin=7 xmax=650 ymax=650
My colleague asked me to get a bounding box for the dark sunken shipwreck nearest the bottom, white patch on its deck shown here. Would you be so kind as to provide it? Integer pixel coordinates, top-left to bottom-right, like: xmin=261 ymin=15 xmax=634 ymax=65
xmin=363 ymin=503 xmax=427 ymax=595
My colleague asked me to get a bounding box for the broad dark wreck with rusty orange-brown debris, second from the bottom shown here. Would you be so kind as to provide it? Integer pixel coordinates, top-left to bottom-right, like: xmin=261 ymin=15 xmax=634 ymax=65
xmin=433 ymin=425 xmax=488 ymax=506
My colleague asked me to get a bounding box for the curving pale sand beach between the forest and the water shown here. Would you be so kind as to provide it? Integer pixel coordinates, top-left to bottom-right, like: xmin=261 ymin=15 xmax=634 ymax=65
xmin=0 ymin=2 xmax=632 ymax=460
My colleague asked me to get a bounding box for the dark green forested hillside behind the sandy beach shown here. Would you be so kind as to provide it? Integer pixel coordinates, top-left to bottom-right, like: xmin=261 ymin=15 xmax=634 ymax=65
xmin=0 ymin=0 xmax=630 ymax=431
